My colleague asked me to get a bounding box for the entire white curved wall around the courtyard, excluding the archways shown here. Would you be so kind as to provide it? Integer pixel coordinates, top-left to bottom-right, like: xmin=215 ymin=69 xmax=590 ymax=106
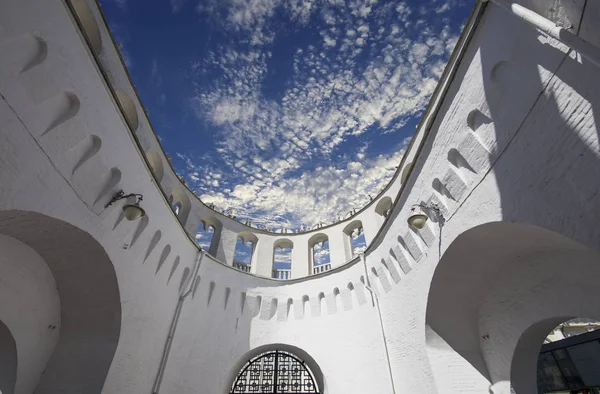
xmin=0 ymin=0 xmax=600 ymax=394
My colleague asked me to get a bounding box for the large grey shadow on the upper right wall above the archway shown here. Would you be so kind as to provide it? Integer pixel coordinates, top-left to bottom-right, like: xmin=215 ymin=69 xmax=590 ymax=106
xmin=475 ymin=2 xmax=600 ymax=249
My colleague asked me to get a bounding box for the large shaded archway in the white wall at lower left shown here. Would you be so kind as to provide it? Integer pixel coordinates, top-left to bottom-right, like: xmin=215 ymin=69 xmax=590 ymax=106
xmin=0 ymin=210 xmax=121 ymax=393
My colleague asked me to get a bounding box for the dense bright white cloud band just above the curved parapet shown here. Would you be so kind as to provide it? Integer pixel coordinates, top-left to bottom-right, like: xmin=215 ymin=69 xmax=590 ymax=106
xmin=188 ymin=139 xmax=409 ymax=229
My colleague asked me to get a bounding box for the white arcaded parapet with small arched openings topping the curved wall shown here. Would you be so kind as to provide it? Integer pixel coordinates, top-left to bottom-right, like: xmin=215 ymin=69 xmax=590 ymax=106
xmin=72 ymin=0 xmax=414 ymax=279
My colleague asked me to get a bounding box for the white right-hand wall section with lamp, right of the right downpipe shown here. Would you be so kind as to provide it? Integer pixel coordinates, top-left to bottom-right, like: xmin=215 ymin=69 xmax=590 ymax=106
xmin=367 ymin=4 xmax=600 ymax=393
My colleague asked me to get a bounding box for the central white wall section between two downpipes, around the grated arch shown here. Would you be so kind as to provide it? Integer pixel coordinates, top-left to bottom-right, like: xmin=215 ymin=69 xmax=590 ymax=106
xmin=163 ymin=257 xmax=391 ymax=393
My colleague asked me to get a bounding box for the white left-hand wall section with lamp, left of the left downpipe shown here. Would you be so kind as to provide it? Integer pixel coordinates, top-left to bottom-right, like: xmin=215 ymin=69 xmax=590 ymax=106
xmin=0 ymin=1 xmax=197 ymax=393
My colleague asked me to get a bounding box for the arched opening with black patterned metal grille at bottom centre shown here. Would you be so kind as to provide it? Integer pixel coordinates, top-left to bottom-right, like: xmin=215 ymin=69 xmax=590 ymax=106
xmin=225 ymin=344 xmax=327 ymax=394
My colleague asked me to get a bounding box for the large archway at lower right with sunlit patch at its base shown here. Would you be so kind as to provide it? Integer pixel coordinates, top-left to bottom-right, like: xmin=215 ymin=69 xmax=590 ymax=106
xmin=426 ymin=222 xmax=600 ymax=394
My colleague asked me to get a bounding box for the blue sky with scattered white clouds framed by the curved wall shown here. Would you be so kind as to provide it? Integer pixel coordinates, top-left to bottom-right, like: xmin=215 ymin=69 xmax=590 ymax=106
xmin=100 ymin=0 xmax=474 ymax=234
